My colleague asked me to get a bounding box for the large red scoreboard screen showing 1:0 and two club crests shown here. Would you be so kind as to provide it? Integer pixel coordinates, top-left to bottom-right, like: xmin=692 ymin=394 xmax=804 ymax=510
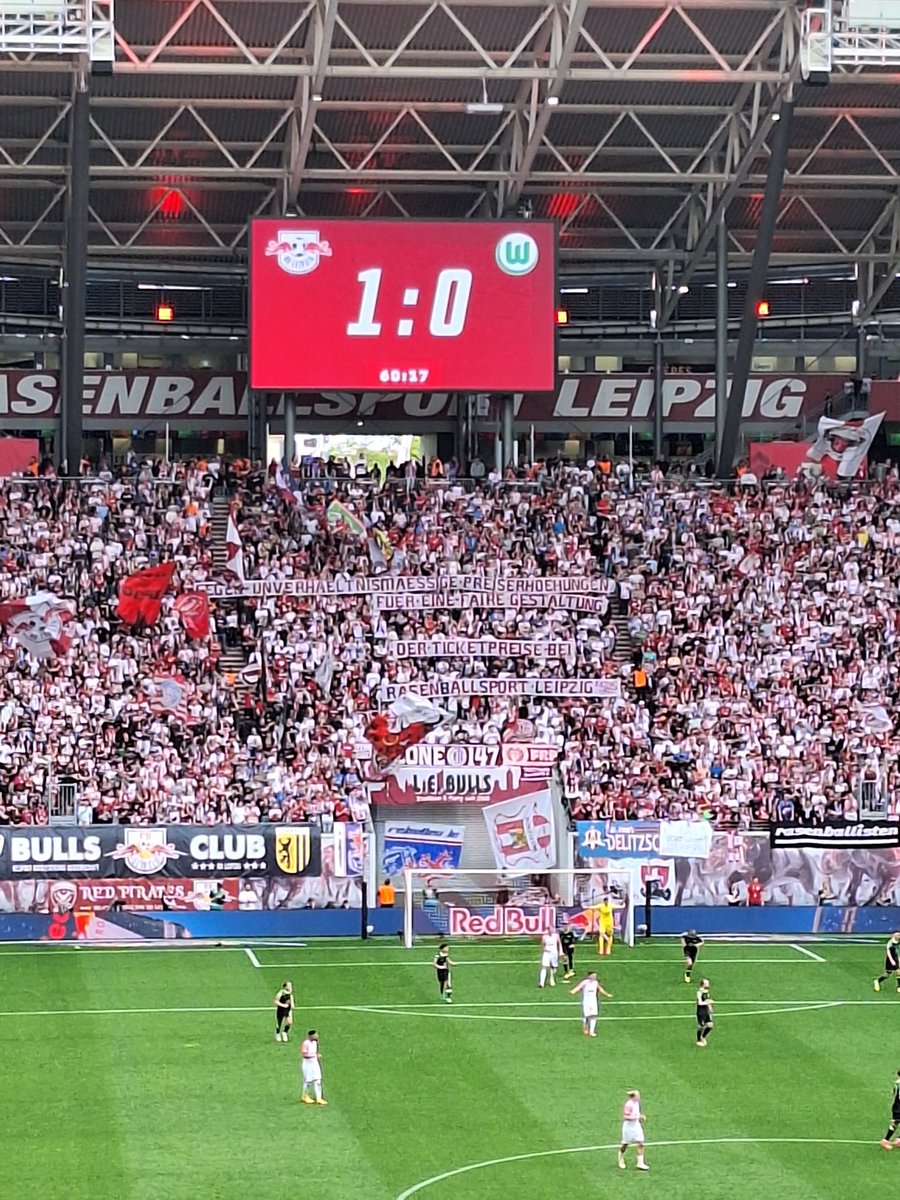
xmin=250 ymin=217 xmax=557 ymax=391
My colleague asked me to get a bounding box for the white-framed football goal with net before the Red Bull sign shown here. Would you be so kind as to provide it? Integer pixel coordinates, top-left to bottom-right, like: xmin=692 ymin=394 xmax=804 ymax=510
xmin=403 ymin=869 xmax=635 ymax=948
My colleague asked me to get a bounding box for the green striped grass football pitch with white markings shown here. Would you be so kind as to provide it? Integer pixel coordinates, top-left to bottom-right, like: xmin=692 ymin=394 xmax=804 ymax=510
xmin=0 ymin=940 xmax=900 ymax=1200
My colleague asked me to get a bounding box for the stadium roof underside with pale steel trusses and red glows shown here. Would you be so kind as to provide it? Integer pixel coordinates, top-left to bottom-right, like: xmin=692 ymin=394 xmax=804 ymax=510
xmin=0 ymin=0 xmax=900 ymax=278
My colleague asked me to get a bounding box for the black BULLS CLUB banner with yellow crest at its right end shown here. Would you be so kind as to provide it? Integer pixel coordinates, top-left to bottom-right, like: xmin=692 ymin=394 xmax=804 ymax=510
xmin=0 ymin=824 xmax=322 ymax=880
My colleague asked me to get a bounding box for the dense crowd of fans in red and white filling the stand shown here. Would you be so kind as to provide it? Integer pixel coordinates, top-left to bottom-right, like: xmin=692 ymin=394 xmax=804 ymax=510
xmin=0 ymin=461 xmax=900 ymax=828
